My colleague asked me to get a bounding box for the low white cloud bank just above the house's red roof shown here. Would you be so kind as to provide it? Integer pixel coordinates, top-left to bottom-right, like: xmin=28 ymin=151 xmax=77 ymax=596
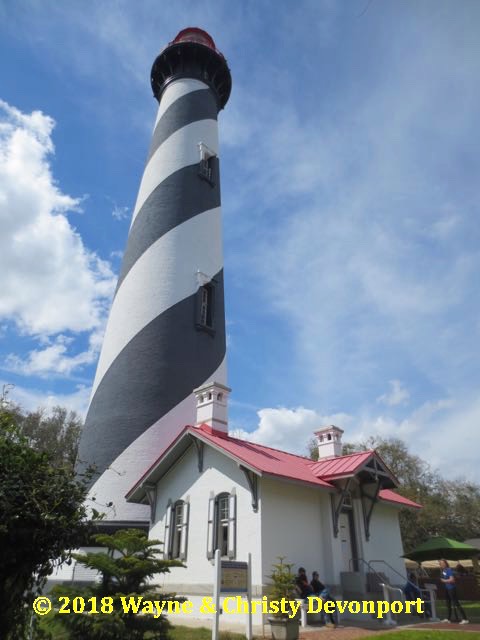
xmin=244 ymin=397 xmax=480 ymax=482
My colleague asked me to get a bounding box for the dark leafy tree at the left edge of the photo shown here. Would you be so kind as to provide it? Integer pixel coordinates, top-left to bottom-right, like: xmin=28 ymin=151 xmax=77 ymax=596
xmin=0 ymin=398 xmax=89 ymax=640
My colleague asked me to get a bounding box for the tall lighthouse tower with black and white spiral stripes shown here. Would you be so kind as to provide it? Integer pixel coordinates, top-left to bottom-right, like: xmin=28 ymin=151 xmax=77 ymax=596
xmin=79 ymin=28 xmax=231 ymax=525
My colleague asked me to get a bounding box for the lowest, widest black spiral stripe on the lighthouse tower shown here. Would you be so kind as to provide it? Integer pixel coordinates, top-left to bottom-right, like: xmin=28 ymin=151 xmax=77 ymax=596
xmin=79 ymin=270 xmax=226 ymax=474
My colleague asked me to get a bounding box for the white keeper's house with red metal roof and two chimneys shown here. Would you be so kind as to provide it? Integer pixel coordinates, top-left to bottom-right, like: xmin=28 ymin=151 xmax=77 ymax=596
xmin=127 ymin=383 xmax=419 ymax=623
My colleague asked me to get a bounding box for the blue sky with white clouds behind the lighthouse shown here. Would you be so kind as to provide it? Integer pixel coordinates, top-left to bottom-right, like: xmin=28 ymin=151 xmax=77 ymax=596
xmin=0 ymin=0 xmax=480 ymax=480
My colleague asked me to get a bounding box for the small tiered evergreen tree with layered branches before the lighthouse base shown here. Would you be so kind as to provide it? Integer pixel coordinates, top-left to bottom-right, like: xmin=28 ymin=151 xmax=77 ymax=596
xmin=55 ymin=529 xmax=184 ymax=640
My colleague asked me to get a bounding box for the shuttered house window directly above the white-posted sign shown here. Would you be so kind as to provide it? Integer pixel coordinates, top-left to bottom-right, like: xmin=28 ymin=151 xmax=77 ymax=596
xmin=207 ymin=493 xmax=237 ymax=559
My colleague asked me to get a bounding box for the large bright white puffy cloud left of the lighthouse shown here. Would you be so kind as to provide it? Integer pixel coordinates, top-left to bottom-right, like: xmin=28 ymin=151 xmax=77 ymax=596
xmin=0 ymin=101 xmax=115 ymax=338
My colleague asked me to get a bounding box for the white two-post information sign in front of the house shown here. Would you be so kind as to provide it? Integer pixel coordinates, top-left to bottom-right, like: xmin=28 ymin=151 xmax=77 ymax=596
xmin=212 ymin=549 xmax=253 ymax=640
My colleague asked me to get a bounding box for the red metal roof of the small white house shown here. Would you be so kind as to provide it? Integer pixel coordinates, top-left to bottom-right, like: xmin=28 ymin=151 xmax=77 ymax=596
xmin=127 ymin=424 xmax=421 ymax=508
